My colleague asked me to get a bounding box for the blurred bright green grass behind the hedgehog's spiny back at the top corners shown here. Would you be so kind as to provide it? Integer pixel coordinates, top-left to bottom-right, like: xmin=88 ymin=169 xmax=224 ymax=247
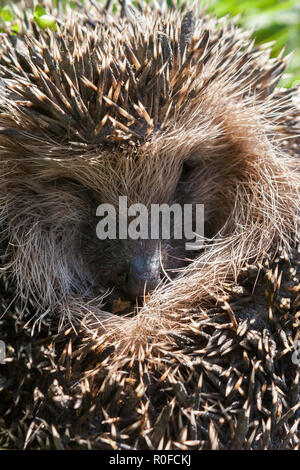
xmin=0 ymin=0 xmax=300 ymax=87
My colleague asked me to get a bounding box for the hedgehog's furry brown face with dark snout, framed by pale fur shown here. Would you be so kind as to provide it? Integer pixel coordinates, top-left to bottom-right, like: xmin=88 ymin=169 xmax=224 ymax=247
xmin=73 ymin=139 xmax=232 ymax=303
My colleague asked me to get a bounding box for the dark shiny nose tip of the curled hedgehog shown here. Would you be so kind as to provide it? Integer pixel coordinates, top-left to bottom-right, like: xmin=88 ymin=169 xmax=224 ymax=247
xmin=125 ymin=255 xmax=160 ymax=300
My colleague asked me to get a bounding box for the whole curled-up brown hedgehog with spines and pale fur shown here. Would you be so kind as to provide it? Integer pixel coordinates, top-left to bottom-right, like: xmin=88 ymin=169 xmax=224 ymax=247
xmin=0 ymin=2 xmax=300 ymax=449
